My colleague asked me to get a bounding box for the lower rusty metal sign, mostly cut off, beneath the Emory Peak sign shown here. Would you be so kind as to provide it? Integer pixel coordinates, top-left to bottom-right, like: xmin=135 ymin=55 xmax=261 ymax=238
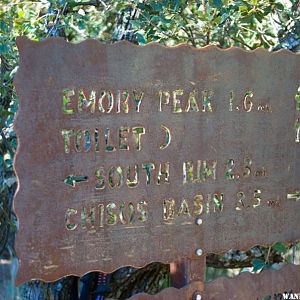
xmin=130 ymin=265 xmax=300 ymax=300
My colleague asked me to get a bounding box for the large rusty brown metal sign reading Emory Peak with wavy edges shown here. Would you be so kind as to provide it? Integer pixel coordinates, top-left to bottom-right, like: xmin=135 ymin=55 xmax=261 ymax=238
xmin=14 ymin=38 xmax=300 ymax=283
